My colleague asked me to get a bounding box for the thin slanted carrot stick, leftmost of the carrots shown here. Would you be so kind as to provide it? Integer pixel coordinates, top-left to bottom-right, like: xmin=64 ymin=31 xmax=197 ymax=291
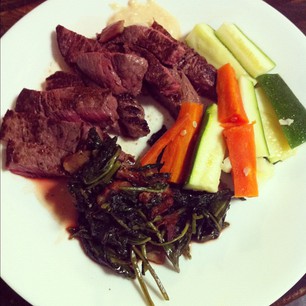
xmin=140 ymin=113 xmax=190 ymax=166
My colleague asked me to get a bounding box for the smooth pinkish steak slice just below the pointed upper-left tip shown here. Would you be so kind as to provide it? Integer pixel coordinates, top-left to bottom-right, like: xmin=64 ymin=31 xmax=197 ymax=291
xmin=76 ymin=52 xmax=148 ymax=96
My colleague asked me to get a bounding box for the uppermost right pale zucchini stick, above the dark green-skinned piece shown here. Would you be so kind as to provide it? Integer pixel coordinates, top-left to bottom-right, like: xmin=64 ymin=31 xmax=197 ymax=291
xmin=215 ymin=23 xmax=275 ymax=78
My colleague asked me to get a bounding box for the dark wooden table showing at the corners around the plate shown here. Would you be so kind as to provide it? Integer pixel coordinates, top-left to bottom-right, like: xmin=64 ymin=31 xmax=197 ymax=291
xmin=0 ymin=0 xmax=306 ymax=306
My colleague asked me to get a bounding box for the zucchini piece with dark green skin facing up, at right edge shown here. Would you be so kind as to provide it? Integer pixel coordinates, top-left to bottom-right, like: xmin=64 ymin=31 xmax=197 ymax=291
xmin=257 ymin=74 xmax=306 ymax=149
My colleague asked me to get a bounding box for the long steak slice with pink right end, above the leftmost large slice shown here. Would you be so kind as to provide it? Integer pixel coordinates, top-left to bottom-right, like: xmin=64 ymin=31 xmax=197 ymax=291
xmin=15 ymin=86 xmax=118 ymax=130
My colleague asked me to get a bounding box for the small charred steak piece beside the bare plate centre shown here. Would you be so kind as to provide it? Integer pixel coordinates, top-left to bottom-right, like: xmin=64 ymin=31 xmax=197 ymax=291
xmin=117 ymin=94 xmax=150 ymax=138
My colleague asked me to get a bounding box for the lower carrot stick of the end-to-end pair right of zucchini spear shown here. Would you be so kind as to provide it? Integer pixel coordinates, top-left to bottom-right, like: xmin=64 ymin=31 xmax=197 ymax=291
xmin=223 ymin=124 xmax=258 ymax=197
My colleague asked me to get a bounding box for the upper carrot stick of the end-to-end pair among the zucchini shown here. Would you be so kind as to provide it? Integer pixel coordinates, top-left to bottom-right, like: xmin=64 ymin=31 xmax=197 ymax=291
xmin=217 ymin=64 xmax=248 ymax=126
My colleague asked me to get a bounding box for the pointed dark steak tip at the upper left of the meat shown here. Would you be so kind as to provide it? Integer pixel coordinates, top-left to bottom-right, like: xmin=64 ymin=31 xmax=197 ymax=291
xmin=56 ymin=25 xmax=103 ymax=66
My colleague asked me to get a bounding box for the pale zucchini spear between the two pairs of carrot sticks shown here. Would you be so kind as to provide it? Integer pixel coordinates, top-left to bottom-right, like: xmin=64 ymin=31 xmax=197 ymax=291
xmin=185 ymin=104 xmax=225 ymax=192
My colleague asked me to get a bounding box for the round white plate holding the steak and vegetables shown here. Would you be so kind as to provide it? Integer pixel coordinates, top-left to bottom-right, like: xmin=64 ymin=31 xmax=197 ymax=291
xmin=1 ymin=0 xmax=306 ymax=306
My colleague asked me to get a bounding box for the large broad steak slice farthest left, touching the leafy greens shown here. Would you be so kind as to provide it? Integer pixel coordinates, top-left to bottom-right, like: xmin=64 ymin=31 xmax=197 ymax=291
xmin=0 ymin=110 xmax=88 ymax=177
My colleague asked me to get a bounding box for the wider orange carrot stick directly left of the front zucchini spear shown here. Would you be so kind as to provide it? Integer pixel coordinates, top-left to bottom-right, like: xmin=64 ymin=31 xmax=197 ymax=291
xmin=161 ymin=102 xmax=204 ymax=183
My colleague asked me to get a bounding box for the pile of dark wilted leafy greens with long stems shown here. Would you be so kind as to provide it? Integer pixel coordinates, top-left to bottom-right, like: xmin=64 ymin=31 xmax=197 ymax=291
xmin=68 ymin=129 xmax=233 ymax=304
